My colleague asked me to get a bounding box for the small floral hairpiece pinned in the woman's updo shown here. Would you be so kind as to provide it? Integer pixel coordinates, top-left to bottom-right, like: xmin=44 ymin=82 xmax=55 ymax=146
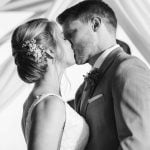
xmin=22 ymin=39 xmax=46 ymax=63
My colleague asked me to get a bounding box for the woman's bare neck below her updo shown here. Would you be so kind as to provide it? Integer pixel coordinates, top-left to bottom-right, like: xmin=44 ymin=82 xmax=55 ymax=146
xmin=34 ymin=64 xmax=64 ymax=95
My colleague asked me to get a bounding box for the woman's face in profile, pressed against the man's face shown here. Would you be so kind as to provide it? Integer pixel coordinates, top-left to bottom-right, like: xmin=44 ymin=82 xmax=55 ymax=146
xmin=57 ymin=27 xmax=75 ymax=67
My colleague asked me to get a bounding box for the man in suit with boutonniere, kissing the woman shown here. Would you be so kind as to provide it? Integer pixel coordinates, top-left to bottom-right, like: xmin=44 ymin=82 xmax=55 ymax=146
xmin=57 ymin=0 xmax=150 ymax=150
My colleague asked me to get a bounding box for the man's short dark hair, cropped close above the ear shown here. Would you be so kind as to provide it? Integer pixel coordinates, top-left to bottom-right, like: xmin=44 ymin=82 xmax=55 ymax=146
xmin=57 ymin=0 xmax=117 ymax=29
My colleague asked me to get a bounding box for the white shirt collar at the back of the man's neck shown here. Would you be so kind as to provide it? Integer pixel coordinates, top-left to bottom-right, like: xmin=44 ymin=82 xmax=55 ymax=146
xmin=93 ymin=44 xmax=120 ymax=68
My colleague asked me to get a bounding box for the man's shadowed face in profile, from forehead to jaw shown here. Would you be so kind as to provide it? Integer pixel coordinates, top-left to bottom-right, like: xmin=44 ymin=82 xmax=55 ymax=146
xmin=63 ymin=20 xmax=94 ymax=64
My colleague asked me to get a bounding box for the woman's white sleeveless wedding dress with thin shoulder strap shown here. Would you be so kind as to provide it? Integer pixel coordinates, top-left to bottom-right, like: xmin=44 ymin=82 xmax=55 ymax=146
xmin=22 ymin=93 xmax=89 ymax=150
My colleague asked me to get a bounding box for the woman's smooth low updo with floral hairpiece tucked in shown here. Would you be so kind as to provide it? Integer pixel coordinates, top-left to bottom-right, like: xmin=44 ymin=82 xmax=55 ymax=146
xmin=11 ymin=18 xmax=62 ymax=83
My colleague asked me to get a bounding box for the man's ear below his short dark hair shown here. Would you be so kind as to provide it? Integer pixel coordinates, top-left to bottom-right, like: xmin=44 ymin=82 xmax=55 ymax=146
xmin=91 ymin=17 xmax=101 ymax=32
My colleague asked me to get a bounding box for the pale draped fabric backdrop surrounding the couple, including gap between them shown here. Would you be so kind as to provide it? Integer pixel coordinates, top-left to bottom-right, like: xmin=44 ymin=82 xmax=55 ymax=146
xmin=0 ymin=0 xmax=150 ymax=150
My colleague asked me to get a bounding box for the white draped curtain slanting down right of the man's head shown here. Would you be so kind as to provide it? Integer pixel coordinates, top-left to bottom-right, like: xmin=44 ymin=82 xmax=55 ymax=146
xmin=105 ymin=0 xmax=150 ymax=63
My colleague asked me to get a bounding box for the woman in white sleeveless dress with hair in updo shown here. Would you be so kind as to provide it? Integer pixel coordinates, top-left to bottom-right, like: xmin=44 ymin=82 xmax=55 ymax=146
xmin=11 ymin=18 xmax=89 ymax=150
